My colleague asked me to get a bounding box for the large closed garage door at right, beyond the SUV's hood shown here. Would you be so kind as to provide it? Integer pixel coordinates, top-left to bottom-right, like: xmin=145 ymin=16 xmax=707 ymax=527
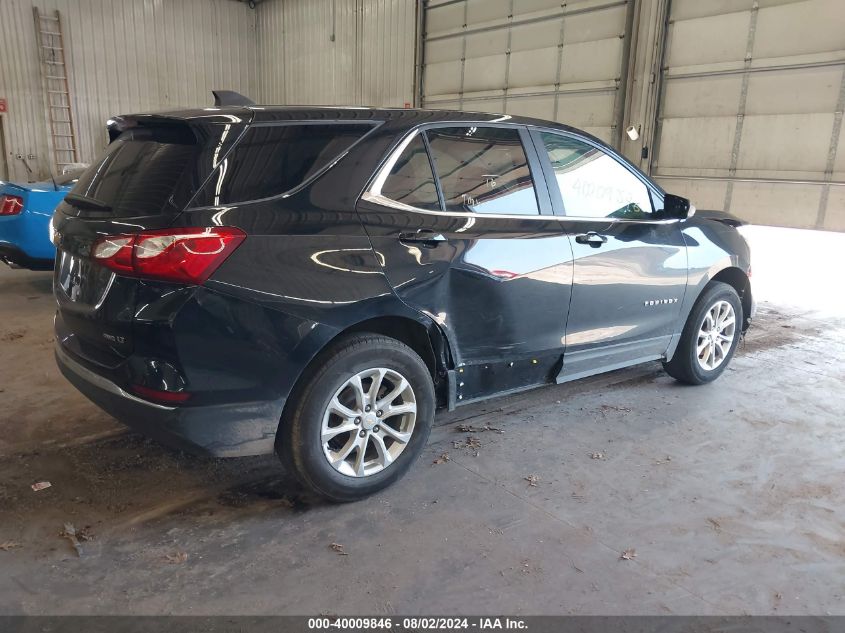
xmin=651 ymin=0 xmax=845 ymax=230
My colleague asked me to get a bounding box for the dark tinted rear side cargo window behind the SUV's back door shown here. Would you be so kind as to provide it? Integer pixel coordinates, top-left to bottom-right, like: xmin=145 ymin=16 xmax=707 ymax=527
xmin=192 ymin=123 xmax=373 ymax=206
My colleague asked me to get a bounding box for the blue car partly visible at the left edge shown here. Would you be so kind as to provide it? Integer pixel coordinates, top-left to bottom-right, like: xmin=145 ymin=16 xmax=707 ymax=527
xmin=0 ymin=170 xmax=82 ymax=270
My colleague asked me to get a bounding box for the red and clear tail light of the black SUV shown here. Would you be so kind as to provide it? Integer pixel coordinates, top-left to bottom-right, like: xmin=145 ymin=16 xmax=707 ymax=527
xmin=91 ymin=226 xmax=246 ymax=285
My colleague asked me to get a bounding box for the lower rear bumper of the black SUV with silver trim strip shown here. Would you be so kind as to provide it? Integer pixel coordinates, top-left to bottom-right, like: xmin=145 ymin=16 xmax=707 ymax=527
xmin=55 ymin=343 xmax=279 ymax=457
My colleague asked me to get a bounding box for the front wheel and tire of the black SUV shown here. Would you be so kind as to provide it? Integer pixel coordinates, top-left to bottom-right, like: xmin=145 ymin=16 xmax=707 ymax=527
xmin=663 ymin=281 xmax=743 ymax=385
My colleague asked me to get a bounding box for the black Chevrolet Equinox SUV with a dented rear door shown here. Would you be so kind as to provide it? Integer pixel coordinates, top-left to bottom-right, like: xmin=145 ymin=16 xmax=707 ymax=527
xmin=51 ymin=106 xmax=754 ymax=501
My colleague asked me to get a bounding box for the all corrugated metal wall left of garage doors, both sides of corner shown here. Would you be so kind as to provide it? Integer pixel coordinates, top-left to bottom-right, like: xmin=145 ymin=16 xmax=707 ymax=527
xmin=0 ymin=0 xmax=416 ymax=180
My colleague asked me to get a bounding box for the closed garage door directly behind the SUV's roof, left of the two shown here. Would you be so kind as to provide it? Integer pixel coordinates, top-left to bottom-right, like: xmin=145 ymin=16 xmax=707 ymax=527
xmin=421 ymin=0 xmax=630 ymax=142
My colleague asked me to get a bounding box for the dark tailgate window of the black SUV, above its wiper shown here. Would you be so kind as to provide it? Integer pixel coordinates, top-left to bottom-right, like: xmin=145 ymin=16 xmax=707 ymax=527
xmin=68 ymin=126 xmax=198 ymax=217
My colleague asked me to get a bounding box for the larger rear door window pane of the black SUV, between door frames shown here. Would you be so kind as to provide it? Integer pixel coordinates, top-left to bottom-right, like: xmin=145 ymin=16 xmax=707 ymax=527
xmin=426 ymin=126 xmax=540 ymax=215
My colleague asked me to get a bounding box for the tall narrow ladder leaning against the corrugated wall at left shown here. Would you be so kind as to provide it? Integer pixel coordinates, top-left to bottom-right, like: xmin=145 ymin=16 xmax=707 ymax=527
xmin=32 ymin=7 xmax=78 ymax=174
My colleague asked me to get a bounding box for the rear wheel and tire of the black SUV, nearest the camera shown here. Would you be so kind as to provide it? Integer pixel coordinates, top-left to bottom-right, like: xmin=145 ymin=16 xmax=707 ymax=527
xmin=276 ymin=333 xmax=435 ymax=502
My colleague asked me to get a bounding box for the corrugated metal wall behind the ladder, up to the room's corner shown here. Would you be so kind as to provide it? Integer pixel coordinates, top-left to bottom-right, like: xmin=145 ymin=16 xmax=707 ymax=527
xmin=0 ymin=0 xmax=259 ymax=180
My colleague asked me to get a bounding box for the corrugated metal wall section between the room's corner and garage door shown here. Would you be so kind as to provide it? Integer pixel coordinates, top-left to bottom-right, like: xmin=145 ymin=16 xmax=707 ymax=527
xmin=257 ymin=0 xmax=416 ymax=107
